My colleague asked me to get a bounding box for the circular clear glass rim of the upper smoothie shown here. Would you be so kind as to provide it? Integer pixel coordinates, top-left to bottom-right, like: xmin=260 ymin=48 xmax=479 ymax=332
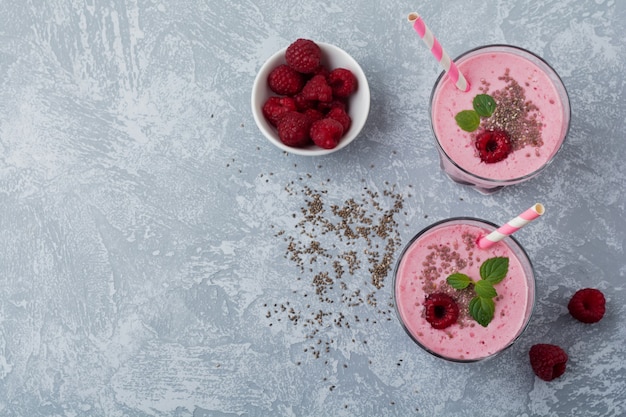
xmin=428 ymin=43 xmax=572 ymax=187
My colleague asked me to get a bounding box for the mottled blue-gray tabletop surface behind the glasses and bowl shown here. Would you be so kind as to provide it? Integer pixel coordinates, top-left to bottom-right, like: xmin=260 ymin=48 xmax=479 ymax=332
xmin=0 ymin=0 xmax=626 ymax=417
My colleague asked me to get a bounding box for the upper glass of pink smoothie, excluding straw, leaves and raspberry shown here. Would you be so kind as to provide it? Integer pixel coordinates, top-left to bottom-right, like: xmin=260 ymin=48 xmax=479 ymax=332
xmin=430 ymin=45 xmax=571 ymax=194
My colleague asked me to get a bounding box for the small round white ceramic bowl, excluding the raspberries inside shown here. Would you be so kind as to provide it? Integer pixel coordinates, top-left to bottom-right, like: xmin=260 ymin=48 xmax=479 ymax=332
xmin=252 ymin=41 xmax=370 ymax=156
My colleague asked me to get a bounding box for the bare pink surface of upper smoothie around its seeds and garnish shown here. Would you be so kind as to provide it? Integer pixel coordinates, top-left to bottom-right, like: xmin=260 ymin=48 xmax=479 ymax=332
xmin=432 ymin=48 xmax=567 ymax=180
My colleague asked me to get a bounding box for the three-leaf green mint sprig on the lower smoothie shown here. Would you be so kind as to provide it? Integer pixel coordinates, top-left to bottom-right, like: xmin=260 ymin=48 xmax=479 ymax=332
xmin=446 ymin=257 xmax=509 ymax=327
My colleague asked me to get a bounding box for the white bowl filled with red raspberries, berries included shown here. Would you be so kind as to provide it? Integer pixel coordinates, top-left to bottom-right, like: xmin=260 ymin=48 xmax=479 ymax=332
xmin=252 ymin=38 xmax=370 ymax=156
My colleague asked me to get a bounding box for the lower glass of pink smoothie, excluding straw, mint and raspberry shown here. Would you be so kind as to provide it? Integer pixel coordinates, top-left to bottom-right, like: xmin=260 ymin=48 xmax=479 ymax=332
xmin=394 ymin=217 xmax=535 ymax=362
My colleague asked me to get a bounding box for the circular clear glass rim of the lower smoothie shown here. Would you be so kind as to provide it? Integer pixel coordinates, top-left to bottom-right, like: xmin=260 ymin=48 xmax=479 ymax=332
xmin=393 ymin=216 xmax=537 ymax=363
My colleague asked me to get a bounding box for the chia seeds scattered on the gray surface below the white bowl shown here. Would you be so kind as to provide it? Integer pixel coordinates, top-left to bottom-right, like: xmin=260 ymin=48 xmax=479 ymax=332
xmin=264 ymin=174 xmax=404 ymax=359
